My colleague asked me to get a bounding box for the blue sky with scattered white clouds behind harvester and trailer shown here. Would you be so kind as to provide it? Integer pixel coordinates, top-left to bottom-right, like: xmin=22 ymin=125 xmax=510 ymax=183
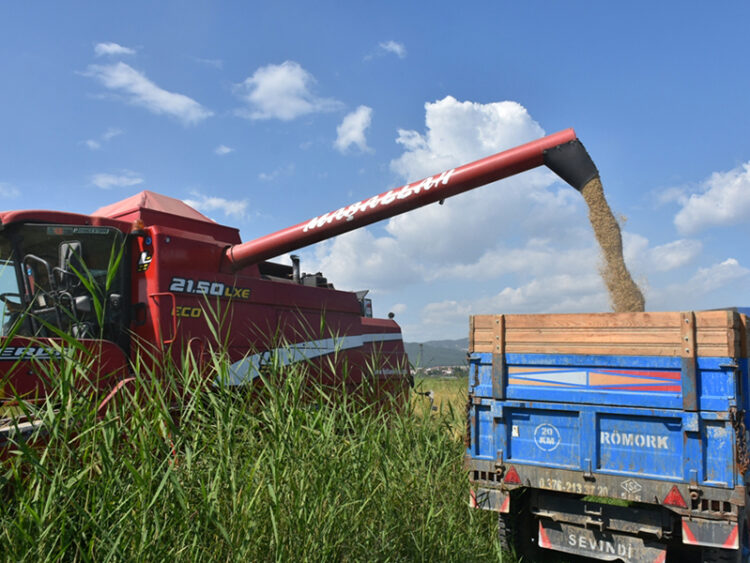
xmin=0 ymin=1 xmax=750 ymax=340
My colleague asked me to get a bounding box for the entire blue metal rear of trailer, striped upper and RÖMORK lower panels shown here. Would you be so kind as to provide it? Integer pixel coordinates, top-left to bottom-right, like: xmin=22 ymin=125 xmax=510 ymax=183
xmin=467 ymin=354 xmax=748 ymax=490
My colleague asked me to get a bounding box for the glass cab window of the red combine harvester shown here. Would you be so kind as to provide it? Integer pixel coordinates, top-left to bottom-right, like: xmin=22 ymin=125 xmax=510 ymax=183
xmin=0 ymin=224 xmax=124 ymax=340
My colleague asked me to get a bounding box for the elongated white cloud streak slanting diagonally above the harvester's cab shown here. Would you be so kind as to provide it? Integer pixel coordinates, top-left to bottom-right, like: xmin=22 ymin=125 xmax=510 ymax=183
xmin=84 ymin=62 xmax=213 ymax=125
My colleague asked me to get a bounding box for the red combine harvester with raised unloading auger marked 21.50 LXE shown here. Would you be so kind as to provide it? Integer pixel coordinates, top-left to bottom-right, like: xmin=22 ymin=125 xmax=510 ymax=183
xmin=0 ymin=129 xmax=597 ymax=445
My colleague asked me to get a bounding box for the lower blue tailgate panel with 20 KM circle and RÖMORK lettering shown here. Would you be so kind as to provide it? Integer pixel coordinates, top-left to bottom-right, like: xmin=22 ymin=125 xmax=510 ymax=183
xmin=467 ymin=399 xmax=740 ymax=487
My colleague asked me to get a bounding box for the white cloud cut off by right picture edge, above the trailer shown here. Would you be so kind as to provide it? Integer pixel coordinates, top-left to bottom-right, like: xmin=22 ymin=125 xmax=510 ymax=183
xmin=669 ymin=162 xmax=750 ymax=235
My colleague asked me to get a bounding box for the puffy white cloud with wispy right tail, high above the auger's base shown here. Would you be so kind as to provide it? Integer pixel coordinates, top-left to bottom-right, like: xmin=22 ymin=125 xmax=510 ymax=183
xmin=235 ymin=61 xmax=341 ymax=121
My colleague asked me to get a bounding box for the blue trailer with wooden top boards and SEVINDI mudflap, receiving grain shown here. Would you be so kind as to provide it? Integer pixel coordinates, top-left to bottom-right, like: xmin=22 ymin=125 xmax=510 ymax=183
xmin=465 ymin=309 xmax=750 ymax=563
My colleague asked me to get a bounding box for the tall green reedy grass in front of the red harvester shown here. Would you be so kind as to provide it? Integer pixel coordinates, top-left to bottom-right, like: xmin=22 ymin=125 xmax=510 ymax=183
xmin=0 ymin=346 xmax=502 ymax=561
